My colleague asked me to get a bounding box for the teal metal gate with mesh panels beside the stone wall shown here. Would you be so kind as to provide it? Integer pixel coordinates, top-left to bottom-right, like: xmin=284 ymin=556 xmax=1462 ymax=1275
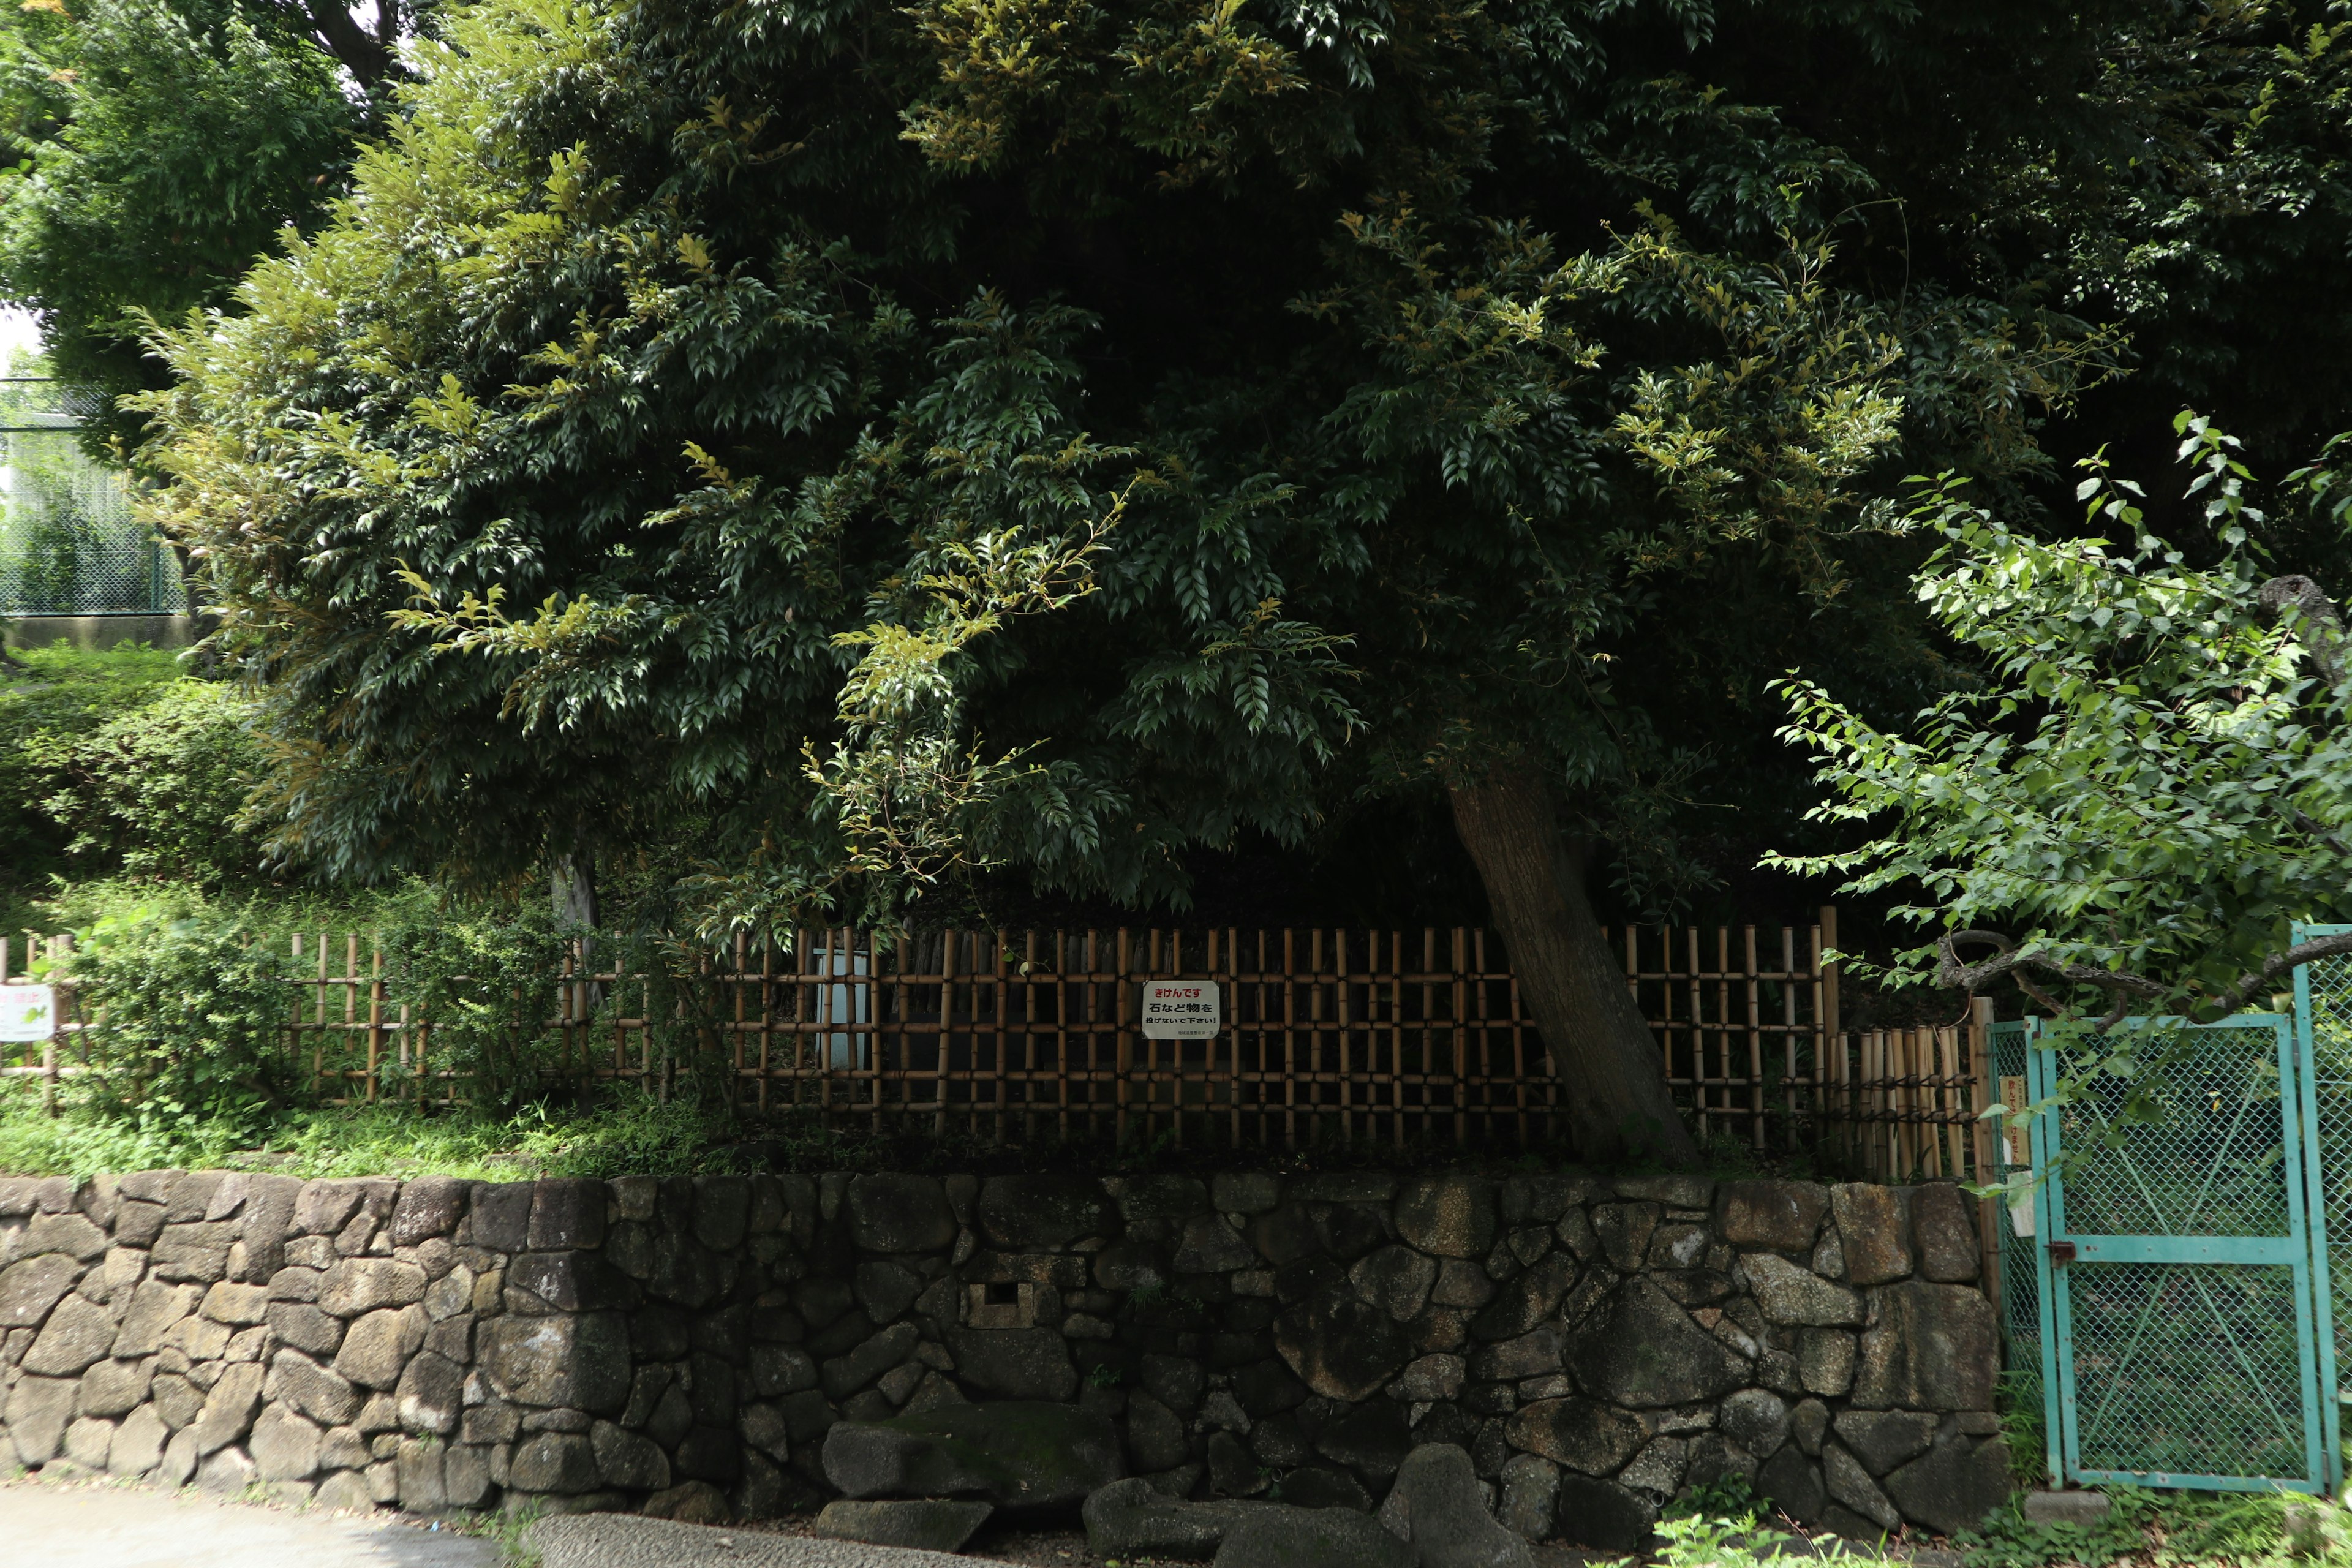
xmin=2022 ymin=1011 xmax=2352 ymax=1493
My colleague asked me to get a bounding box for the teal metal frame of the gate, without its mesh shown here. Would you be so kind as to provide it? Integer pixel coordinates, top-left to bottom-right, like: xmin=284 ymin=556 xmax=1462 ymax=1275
xmin=2025 ymin=1011 xmax=2343 ymax=1495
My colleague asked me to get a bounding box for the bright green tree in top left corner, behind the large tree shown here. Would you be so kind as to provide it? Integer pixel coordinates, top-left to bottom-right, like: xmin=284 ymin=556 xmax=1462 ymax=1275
xmin=0 ymin=0 xmax=433 ymax=447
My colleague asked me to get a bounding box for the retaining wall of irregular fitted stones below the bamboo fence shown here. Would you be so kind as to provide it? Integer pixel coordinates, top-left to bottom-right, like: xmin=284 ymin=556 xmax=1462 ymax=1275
xmin=0 ymin=1170 xmax=2007 ymax=1547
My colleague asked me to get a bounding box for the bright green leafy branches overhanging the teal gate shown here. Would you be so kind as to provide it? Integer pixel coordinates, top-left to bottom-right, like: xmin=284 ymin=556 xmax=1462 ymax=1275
xmin=1787 ymin=414 xmax=2352 ymax=1023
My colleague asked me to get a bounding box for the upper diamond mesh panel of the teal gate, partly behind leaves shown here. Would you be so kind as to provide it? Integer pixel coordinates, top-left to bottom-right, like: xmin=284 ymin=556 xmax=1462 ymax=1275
xmin=2058 ymin=1027 xmax=2291 ymax=1237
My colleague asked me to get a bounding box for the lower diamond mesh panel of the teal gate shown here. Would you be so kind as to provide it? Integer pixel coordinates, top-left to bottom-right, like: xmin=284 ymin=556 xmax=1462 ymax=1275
xmin=2067 ymin=1262 xmax=2305 ymax=1479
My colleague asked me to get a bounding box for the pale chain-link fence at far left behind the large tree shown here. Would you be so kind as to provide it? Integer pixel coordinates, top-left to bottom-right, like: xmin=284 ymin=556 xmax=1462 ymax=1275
xmin=0 ymin=376 xmax=188 ymax=616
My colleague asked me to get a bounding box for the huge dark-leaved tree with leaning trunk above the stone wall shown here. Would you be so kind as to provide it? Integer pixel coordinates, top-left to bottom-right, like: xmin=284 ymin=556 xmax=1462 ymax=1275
xmin=143 ymin=0 xmax=2323 ymax=1159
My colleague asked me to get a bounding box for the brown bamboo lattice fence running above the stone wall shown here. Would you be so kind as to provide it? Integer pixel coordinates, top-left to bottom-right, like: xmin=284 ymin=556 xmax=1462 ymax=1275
xmin=0 ymin=907 xmax=1985 ymax=1180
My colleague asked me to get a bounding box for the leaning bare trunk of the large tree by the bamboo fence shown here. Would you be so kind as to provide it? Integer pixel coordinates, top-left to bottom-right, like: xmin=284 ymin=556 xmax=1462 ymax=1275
xmin=1447 ymin=762 xmax=1698 ymax=1169
